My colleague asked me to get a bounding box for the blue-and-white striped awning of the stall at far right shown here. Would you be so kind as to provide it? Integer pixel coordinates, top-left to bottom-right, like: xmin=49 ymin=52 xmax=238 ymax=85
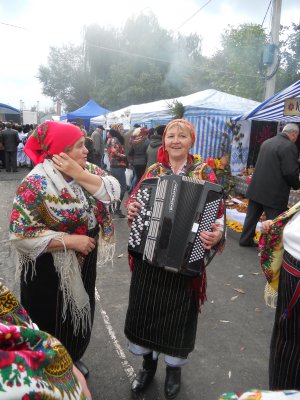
xmin=232 ymin=80 xmax=300 ymax=122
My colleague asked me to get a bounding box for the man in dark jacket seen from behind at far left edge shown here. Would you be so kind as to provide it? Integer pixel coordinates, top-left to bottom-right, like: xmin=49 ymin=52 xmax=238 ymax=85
xmin=2 ymin=122 xmax=21 ymax=172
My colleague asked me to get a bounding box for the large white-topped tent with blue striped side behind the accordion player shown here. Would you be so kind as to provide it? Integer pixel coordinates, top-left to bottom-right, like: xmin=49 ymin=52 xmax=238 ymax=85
xmin=91 ymin=89 xmax=258 ymax=159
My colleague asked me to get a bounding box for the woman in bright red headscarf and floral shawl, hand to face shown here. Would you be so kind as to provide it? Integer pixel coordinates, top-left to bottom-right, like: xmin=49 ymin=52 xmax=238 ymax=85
xmin=10 ymin=121 xmax=120 ymax=374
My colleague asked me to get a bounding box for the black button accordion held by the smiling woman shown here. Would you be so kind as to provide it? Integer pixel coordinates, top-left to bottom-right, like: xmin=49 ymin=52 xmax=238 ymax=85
xmin=128 ymin=175 xmax=223 ymax=276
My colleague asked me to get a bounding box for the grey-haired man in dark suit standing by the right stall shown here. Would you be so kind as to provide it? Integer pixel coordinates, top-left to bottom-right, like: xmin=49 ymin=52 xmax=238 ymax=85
xmin=240 ymin=124 xmax=300 ymax=246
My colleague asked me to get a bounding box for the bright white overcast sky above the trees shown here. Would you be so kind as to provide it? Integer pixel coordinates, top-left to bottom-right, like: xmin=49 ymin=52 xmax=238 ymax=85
xmin=0 ymin=0 xmax=300 ymax=110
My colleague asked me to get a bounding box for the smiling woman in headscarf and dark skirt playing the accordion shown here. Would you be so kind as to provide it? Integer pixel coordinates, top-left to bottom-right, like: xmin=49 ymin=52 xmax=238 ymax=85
xmin=125 ymin=119 xmax=223 ymax=399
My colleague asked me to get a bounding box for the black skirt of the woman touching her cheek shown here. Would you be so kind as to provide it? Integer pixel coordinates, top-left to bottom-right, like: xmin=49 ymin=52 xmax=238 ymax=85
xmin=21 ymin=228 xmax=99 ymax=362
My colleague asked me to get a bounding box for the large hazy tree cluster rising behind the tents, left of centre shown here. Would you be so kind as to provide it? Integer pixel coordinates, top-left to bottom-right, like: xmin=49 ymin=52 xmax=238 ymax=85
xmin=38 ymin=14 xmax=206 ymax=110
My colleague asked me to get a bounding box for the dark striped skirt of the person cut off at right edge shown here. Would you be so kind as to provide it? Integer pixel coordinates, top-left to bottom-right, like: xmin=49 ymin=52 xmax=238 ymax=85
xmin=269 ymin=252 xmax=300 ymax=390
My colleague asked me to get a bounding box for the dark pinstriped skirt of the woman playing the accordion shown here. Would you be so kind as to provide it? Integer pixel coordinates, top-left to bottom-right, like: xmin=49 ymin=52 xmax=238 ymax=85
xmin=125 ymin=260 xmax=198 ymax=358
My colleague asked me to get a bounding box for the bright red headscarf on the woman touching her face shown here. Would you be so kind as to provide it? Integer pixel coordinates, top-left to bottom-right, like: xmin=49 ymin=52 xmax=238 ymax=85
xmin=24 ymin=121 xmax=83 ymax=164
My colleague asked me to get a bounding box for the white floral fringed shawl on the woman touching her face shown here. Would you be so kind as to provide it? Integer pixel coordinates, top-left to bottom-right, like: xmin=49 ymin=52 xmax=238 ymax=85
xmin=10 ymin=159 xmax=117 ymax=333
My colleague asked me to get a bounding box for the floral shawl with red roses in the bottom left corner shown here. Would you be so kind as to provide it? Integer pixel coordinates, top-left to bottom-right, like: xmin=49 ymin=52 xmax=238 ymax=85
xmin=0 ymin=284 xmax=86 ymax=400
